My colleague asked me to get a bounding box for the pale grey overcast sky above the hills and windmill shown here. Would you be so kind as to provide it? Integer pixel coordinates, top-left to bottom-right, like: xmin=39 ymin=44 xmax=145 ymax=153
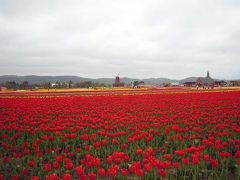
xmin=0 ymin=0 xmax=240 ymax=79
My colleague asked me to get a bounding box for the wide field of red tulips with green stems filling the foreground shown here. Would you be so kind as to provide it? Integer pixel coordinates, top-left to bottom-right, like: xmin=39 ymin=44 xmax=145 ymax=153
xmin=0 ymin=90 xmax=240 ymax=180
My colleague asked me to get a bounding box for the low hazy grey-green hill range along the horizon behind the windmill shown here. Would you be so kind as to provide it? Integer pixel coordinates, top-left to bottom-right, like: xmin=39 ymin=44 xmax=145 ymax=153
xmin=0 ymin=75 xmax=229 ymax=85
